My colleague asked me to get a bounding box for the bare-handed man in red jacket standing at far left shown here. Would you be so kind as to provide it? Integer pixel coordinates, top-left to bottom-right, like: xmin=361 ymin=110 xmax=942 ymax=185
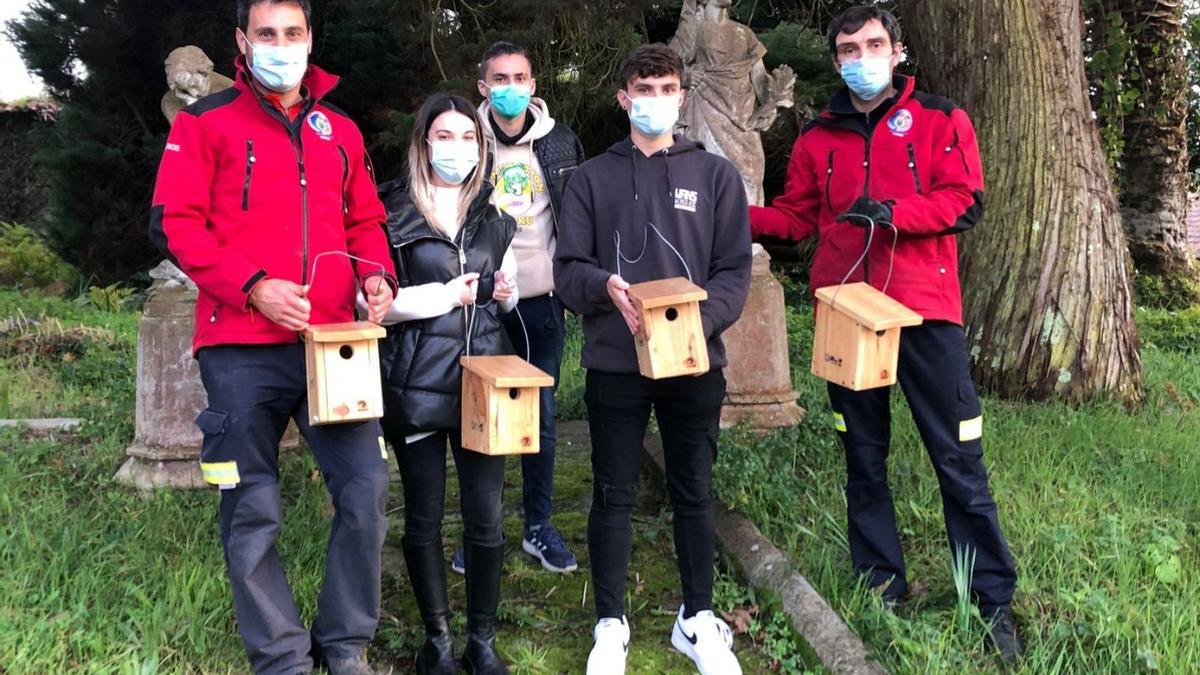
xmin=150 ymin=0 xmax=395 ymax=675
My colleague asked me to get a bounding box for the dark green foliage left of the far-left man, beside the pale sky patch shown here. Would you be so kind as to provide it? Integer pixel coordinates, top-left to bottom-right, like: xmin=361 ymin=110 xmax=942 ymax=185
xmin=7 ymin=0 xmax=234 ymax=283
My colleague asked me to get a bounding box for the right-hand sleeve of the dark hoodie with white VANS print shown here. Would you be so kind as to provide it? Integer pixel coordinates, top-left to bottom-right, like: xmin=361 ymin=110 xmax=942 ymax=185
xmin=700 ymin=163 xmax=752 ymax=339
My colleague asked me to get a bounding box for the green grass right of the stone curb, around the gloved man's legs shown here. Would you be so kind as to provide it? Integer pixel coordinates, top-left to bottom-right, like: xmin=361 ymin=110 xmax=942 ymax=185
xmin=716 ymin=285 xmax=1200 ymax=673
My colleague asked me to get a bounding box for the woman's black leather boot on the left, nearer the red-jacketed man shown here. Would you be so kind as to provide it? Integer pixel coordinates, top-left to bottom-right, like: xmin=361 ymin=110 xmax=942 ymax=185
xmin=403 ymin=542 xmax=456 ymax=675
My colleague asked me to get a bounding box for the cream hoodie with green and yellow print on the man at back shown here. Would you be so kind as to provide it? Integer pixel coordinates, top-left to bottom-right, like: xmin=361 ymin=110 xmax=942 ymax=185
xmin=478 ymin=98 xmax=554 ymax=298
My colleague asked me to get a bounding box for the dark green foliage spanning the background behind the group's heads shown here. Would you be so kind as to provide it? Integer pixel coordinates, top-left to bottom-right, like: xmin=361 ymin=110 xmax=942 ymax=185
xmin=7 ymin=0 xmax=850 ymax=285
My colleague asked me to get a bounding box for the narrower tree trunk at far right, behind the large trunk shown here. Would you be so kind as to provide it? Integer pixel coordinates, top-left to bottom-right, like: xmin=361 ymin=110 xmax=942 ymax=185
xmin=1118 ymin=0 xmax=1195 ymax=294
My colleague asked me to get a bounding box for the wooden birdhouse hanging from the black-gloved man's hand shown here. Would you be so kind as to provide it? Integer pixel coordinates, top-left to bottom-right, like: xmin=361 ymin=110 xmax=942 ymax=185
xmin=812 ymin=282 xmax=924 ymax=392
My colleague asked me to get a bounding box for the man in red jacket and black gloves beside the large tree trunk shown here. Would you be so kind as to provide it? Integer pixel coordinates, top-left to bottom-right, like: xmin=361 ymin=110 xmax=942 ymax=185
xmin=750 ymin=7 xmax=1022 ymax=661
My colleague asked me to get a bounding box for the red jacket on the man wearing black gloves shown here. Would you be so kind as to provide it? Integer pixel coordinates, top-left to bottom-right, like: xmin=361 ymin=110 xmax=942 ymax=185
xmin=750 ymin=76 xmax=983 ymax=325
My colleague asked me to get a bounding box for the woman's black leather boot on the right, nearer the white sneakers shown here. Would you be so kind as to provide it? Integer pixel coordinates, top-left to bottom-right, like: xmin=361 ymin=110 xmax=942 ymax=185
xmin=462 ymin=544 xmax=509 ymax=675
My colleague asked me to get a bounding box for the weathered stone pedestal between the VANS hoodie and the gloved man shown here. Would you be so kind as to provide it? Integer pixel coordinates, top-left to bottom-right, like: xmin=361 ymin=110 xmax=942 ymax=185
xmin=721 ymin=244 xmax=804 ymax=430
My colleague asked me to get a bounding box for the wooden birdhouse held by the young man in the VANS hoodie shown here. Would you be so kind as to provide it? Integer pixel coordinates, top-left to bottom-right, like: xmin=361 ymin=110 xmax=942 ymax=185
xmin=629 ymin=277 xmax=708 ymax=380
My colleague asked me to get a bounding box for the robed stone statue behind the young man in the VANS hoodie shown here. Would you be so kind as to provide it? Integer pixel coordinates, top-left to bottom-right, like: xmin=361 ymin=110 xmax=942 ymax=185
xmin=671 ymin=0 xmax=796 ymax=205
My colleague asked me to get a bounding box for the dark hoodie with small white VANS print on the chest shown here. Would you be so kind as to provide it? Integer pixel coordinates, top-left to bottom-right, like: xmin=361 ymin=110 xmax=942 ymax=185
xmin=554 ymin=136 xmax=751 ymax=372
